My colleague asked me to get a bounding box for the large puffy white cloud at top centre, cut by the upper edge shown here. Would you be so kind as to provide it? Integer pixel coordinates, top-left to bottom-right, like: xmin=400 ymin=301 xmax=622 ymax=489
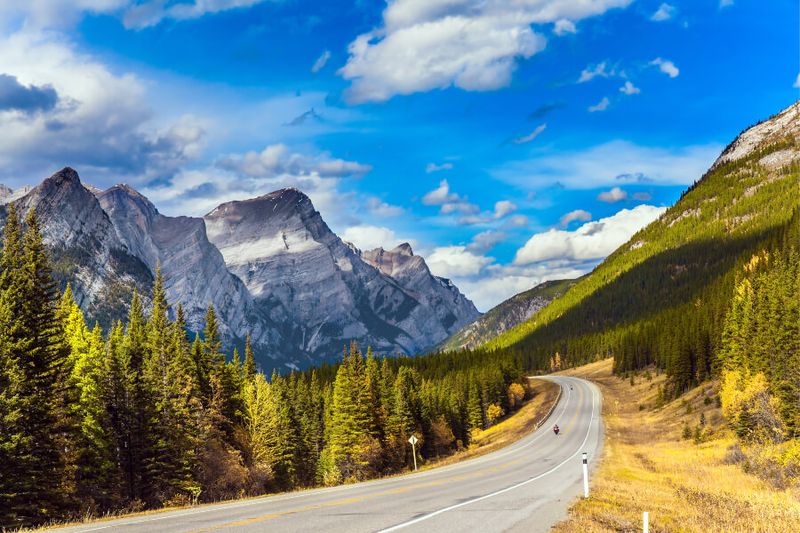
xmin=339 ymin=0 xmax=631 ymax=103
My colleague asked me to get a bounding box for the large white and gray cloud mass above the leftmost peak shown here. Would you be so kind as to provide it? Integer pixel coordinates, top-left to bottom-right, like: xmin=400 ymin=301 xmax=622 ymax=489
xmin=0 ymin=31 xmax=208 ymax=182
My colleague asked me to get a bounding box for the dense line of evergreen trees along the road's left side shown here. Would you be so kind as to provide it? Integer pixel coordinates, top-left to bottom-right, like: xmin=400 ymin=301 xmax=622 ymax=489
xmin=0 ymin=204 xmax=526 ymax=527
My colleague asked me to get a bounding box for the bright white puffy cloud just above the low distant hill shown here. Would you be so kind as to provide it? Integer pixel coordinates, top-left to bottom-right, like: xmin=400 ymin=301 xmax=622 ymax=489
xmin=514 ymin=204 xmax=666 ymax=265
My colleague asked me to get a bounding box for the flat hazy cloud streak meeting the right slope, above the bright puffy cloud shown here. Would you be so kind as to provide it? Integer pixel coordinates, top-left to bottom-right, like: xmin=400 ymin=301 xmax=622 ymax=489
xmin=491 ymin=140 xmax=724 ymax=189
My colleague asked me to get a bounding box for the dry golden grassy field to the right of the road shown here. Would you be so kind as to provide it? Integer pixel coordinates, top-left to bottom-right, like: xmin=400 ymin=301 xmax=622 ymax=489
xmin=555 ymin=359 xmax=800 ymax=532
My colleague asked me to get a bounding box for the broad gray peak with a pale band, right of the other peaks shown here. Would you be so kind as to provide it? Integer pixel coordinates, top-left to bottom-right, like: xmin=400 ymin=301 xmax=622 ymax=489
xmin=205 ymin=189 xmax=477 ymax=360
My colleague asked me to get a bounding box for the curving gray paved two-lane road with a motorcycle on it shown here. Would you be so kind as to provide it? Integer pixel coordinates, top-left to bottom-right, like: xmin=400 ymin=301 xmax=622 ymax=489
xmin=53 ymin=376 xmax=602 ymax=533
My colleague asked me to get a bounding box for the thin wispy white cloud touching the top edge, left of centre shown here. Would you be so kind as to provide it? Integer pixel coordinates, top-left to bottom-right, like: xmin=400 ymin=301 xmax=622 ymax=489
xmin=122 ymin=0 xmax=264 ymax=29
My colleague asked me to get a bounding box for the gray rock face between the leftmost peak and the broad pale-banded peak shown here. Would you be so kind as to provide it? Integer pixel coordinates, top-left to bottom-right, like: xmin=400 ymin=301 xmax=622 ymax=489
xmin=98 ymin=185 xmax=279 ymax=354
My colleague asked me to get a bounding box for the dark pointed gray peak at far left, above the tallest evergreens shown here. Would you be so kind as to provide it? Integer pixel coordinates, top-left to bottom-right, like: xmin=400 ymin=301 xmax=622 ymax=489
xmin=3 ymin=168 xmax=153 ymax=326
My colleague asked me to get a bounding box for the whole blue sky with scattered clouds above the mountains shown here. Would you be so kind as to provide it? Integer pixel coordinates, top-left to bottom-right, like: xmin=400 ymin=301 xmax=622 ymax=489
xmin=0 ymin=0 xmax=800 ymax=311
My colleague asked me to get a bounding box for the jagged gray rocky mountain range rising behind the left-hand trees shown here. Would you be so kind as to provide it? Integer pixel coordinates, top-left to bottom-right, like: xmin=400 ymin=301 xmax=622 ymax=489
xmin=0 ymin=168 xmax=480 ymax=369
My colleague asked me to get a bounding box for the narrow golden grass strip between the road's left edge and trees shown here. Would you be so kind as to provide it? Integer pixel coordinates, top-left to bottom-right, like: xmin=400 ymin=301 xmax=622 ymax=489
xmin=424 ymin=378 xmax=559 ymax=468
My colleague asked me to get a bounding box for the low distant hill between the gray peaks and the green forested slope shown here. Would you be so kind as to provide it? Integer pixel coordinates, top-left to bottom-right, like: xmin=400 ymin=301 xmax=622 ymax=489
xmin=439 ymin=279 xmax=577 ymax=351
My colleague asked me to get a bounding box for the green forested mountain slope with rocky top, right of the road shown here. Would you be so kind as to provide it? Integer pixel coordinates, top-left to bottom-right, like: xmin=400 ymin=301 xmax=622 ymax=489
xmin=486 ymin=103 xmax=800 ymax=392
